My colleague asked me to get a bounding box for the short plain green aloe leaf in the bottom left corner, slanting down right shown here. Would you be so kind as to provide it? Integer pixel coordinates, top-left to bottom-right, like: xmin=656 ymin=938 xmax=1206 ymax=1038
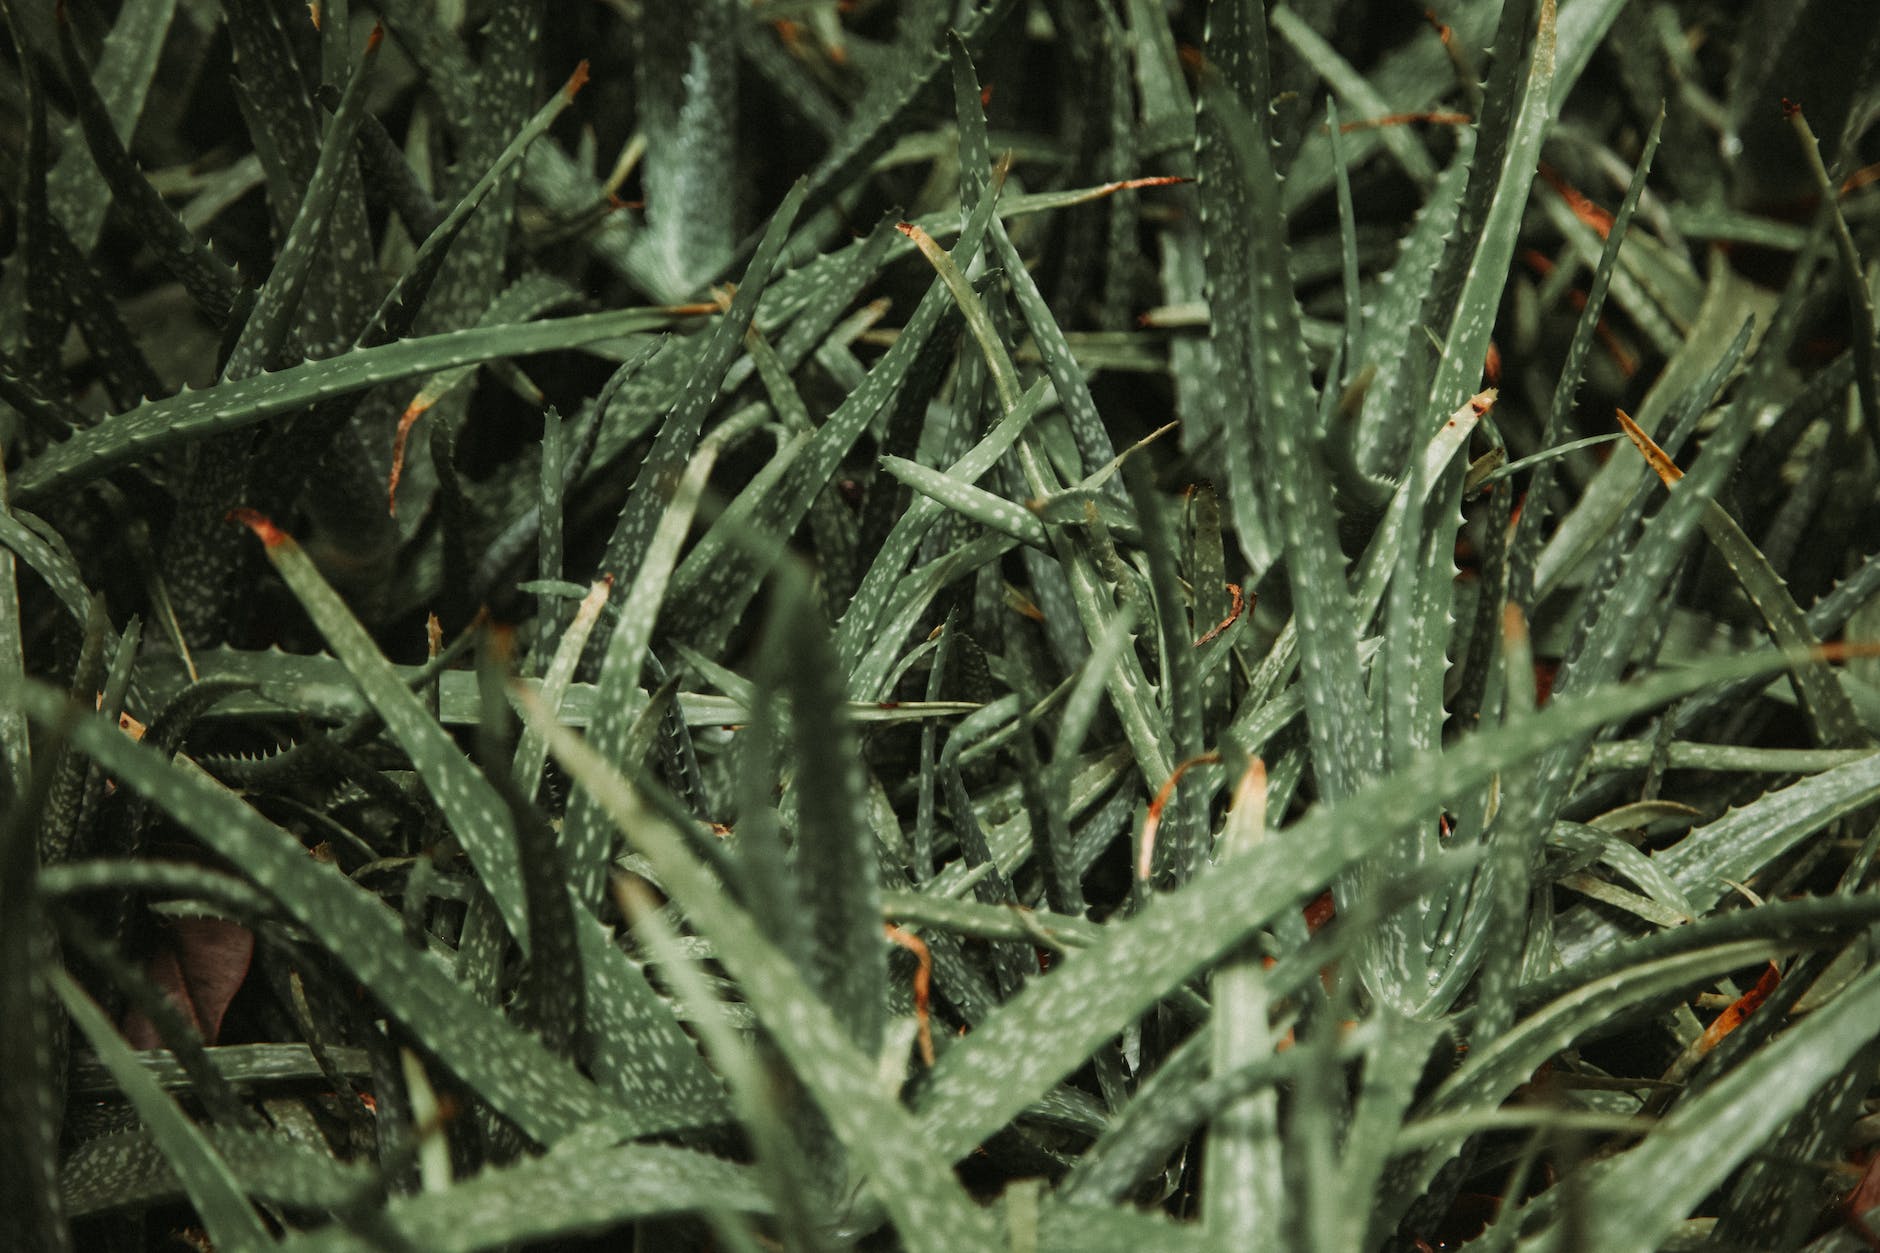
xmin=51 ymin=971 xmax=273 ymax=1249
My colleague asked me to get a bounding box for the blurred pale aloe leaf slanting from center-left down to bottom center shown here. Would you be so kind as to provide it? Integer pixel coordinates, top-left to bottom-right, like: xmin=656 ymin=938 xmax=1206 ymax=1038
xmin=525 ymin=704 xmax=991 ymax=1251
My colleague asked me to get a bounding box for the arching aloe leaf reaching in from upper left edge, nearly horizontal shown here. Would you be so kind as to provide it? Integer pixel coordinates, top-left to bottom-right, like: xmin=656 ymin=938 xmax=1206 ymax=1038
xmin=13 ymin=309 xmax=671 ymax=504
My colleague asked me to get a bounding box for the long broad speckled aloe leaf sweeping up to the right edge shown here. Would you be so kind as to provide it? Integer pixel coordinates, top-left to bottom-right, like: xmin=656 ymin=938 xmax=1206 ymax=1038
xmin=921 ymin=653 xmax=1849 ymax=1155
